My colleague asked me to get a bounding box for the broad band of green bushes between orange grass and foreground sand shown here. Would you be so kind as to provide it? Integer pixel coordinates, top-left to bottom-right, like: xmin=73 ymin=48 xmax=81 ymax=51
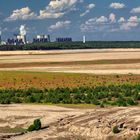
xmin=0 ymin=85 xmax=140 ymax=106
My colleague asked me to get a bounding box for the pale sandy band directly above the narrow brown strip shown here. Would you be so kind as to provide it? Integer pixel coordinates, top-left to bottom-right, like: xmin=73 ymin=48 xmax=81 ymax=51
xmin=0 ymin=51 xmax=140 ymax=63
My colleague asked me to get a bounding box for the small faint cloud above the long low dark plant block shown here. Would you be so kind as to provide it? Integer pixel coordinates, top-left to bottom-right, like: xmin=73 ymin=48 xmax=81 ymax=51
xmin=49 ymin=20 xmax=71 ymax=31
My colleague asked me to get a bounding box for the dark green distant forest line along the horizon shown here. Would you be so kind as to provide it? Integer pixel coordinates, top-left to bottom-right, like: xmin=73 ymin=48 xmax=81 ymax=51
xmin=0 ymin=41 xmax=140 ymax=51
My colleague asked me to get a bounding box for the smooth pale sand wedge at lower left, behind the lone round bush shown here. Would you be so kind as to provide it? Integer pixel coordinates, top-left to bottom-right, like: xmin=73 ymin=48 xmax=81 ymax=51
xmin=0 ymin=104 xmax=86 ymax=128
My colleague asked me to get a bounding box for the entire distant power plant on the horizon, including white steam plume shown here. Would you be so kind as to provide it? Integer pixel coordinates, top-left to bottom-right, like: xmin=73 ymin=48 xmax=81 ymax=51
xmin=0 ymin=25 xmax=72 ymax=45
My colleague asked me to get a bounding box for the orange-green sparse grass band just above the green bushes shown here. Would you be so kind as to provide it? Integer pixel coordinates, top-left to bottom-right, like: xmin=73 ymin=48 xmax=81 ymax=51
xmin=0 ymin=71 xmax=140 ymax=89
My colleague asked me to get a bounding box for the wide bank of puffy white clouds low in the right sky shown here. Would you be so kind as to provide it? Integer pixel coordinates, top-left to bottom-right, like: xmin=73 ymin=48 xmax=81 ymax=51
xmin=80 ymin=13 xmax=140 ymax=32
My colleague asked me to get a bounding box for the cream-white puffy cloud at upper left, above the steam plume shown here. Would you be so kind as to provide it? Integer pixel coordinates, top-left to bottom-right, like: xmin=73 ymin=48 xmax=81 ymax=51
xmin=6 ymin=7 xmax=37 ymax=21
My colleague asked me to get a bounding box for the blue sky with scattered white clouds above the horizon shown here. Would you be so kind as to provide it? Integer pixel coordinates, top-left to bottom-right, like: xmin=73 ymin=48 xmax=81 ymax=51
xmin=0 ymin=0 xmax=140 ymax=41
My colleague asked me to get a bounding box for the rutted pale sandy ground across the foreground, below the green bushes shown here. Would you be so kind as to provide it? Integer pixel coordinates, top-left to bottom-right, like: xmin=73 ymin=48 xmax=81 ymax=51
xmin=0 ymin=105 xmax=140 ymax=140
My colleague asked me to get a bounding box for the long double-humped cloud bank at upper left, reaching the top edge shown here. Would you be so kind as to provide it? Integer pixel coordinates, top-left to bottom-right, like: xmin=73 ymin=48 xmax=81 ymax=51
xmin=6 ymin=0 xmax=79 ymax=21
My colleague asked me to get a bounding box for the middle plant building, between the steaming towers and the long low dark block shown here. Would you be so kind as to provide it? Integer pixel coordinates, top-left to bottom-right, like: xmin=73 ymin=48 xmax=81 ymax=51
xmin=33 ymin=35 xmax=51 ymax=43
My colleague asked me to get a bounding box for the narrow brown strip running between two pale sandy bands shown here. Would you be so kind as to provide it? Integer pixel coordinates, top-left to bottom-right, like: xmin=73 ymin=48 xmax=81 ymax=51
xmin=0 ymin=59 xmax=140 ymax=68
